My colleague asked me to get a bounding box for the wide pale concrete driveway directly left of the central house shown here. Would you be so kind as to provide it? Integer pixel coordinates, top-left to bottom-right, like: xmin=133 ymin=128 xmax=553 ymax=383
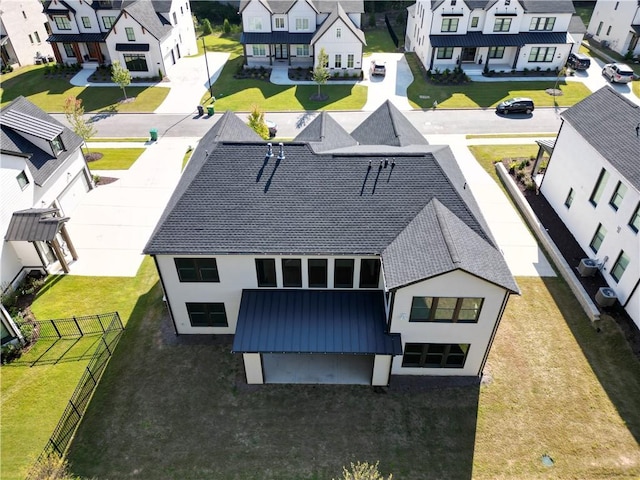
xmin=67 ymin=138 xmax=199 ymax=277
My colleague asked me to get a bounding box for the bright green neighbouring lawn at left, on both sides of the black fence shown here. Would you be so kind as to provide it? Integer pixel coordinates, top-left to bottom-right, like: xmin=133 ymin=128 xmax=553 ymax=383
xmin=0 ymin=258 xmax=157 ymax=480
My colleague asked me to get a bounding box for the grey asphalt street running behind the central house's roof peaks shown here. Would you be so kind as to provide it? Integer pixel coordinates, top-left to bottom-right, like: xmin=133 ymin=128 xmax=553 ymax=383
xmin=53 ymin=108 xmax=561 ymax=138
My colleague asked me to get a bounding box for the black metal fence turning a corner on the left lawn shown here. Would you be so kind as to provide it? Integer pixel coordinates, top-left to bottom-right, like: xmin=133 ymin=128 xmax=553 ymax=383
xmin=27 ymin=312 xmax=124 ymax=480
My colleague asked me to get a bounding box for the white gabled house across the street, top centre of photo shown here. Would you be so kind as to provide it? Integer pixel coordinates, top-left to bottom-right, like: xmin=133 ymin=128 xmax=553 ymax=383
xmin=240 ymin=0 xmax=366 ymax=75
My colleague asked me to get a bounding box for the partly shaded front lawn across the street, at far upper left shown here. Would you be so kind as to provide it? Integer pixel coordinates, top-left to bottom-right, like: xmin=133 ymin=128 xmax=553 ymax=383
xmin=0 ymin=65 xmax=169 ymax=112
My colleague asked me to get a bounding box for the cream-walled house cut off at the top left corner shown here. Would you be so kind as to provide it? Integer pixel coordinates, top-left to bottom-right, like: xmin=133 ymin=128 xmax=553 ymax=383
xmin=0 ymin=0 xmax=53 ymax=66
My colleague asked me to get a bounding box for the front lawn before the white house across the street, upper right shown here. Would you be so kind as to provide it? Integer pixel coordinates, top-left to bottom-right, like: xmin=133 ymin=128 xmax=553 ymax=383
xmin=405 ymin=54 xmax=591 ymax=108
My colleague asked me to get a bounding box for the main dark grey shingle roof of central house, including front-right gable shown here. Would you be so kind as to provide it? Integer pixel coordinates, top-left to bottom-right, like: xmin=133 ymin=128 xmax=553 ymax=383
xmin=145 ymin=109 xmax=517 ymax=291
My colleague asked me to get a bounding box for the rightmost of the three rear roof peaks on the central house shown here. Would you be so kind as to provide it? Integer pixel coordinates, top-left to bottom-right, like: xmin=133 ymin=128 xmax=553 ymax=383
xmin=351 ymin=100 xmax=429 ymax=147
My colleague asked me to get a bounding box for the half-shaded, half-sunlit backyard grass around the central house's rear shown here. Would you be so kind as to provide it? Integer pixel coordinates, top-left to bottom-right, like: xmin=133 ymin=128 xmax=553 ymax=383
xmin=61 ymin=278 xmax=640 ymax=480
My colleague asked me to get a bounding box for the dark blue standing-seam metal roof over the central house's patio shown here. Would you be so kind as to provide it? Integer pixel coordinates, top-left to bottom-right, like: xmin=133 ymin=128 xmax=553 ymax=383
xmin=232 ymin=290 xmax=402 ymax=355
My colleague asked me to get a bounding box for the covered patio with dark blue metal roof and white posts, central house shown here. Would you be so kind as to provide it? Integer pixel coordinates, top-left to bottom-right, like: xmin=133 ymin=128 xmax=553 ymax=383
xmin=232 ymin=290 xmax=402 ymax=385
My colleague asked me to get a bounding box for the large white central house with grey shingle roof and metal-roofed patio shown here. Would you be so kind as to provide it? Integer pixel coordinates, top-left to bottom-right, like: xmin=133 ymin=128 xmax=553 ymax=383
xmin=145 ymin=101 xmax=518 ymax=385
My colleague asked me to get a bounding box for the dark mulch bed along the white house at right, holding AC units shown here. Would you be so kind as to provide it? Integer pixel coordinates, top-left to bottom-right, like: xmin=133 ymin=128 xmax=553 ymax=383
xmin=506 ymin=164 xmax=640 ymax=359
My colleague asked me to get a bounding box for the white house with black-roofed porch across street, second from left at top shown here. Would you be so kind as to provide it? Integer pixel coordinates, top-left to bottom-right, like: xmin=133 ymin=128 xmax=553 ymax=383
xmin=44 ymin=0 xmax=198 ymax=77
